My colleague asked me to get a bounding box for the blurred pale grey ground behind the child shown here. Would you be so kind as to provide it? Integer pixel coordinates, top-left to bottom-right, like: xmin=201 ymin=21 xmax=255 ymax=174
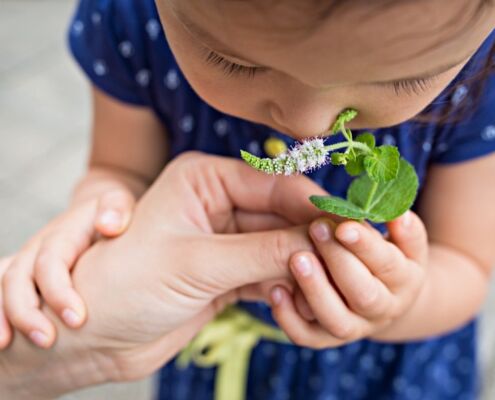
xmin=0 ymin=0 xmax=495 ymax=400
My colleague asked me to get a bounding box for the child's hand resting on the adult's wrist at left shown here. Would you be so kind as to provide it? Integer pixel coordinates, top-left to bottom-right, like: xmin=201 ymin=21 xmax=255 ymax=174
xmin=0 ymin=189 xmax=135 ymax=349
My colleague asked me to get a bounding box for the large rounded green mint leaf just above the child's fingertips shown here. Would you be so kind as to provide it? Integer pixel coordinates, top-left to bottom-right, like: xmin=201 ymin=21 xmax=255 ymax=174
xmin=346 ymin=159 xmax=419 ymax=222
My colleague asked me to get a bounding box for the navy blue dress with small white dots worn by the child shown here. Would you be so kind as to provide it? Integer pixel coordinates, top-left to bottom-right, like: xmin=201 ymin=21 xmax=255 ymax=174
xmin=69 ymin=0 xmax=495 ymax=400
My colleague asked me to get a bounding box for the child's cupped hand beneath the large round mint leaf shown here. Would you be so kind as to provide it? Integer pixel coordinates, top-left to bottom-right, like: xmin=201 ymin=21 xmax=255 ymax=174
xmin=271 ymin=211 xmax=428 ymax=348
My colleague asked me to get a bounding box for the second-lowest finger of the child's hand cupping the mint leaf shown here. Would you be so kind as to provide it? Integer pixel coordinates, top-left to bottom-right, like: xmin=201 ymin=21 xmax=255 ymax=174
xmin=290 ymin=252 xmax=369 ymax=340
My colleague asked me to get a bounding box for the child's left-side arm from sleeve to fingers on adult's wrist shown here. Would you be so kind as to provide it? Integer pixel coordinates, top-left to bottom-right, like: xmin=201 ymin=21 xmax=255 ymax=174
xmin=0 ymin=86 xmax=167 ymax=348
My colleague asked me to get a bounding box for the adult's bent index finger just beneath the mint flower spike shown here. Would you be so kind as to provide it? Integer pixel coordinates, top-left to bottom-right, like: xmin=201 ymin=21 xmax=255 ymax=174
xmin=169 ymin=152 xmax=327 ymax=224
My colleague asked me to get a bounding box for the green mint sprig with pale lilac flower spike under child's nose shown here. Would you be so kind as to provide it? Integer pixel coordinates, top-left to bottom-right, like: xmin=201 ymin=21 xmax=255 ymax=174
xmin=241 ymin=109 xmax=419 ymax=223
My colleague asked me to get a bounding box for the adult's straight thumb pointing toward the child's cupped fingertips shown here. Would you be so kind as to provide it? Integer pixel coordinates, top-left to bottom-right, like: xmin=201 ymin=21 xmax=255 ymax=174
xmin=203 ymin=225 xmax=314 ymax=294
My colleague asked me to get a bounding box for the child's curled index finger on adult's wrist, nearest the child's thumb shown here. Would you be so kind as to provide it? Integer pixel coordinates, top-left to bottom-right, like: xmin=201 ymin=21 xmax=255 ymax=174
xmin=34 ymin=233 xmax=86 ymax=328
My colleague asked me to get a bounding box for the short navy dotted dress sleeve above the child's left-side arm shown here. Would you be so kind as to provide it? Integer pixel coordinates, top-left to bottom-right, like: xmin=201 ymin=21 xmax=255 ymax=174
xmin=68 ymin=0 xmax=157 ymax=106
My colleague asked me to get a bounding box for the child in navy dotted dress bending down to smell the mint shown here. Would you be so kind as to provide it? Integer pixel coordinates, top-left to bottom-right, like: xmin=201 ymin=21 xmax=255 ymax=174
xmin=0 ymin=0 xmax=495 ymax=400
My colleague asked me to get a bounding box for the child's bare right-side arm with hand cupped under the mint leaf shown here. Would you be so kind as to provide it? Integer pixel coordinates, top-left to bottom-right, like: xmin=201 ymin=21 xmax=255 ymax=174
xmin=272 ymin=155 xmax=495 ymax=347
